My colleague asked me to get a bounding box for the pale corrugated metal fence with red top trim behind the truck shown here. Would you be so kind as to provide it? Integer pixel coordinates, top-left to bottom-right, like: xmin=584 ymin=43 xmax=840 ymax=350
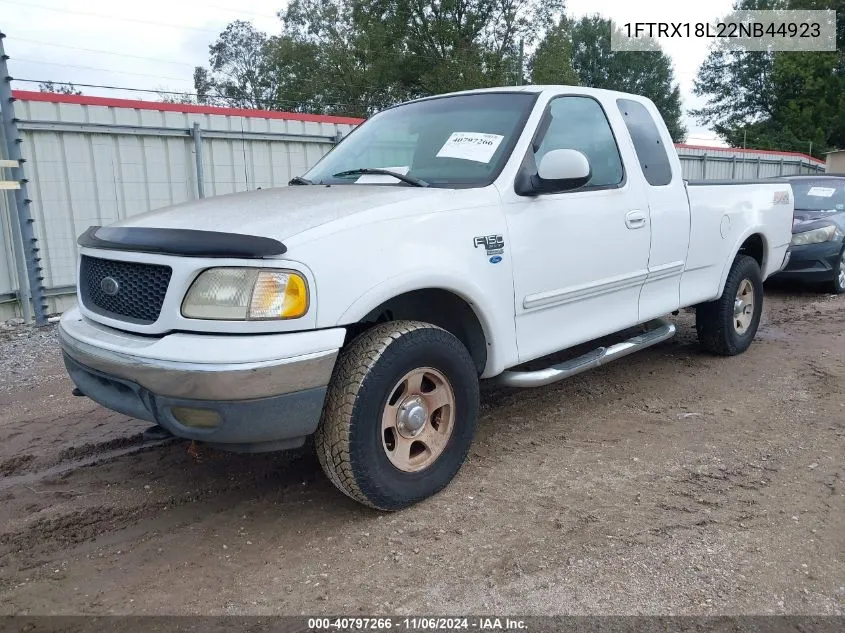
xmin=0 ymin=92 xmax=824 ymax=319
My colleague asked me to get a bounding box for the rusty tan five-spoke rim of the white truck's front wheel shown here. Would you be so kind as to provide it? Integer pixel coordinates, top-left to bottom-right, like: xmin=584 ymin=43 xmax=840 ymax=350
xmin=381 ymin=367 xmax=455 ymax=473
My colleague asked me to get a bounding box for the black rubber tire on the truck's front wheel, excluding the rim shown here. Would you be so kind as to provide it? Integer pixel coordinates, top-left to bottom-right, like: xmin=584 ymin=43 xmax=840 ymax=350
xmin=316 ymin=321 xmax=479 ymax=511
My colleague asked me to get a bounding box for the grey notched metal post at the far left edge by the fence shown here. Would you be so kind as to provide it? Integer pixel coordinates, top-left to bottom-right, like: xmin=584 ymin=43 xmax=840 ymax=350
xmin=0 ymin=32 xmax=47 ymax=325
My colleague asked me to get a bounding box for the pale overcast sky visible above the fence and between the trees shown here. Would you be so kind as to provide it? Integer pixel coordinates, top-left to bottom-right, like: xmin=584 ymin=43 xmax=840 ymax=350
xmin=0 ymin=0 xmax=732 ymax=143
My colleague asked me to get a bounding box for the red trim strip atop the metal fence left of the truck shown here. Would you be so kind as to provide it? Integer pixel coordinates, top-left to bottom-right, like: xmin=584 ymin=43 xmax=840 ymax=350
xmin=12 ymin=90 xmax=364 ymax=125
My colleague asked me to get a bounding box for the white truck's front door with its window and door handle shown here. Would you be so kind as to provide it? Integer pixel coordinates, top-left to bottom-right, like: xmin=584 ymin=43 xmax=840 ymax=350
xmin=506 ymin=95 xmax=650 ymax=362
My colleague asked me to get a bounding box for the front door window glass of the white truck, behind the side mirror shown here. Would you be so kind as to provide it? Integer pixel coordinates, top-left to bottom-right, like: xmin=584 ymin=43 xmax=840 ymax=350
xmin=534 ymin=96 xmax=625 ymax=187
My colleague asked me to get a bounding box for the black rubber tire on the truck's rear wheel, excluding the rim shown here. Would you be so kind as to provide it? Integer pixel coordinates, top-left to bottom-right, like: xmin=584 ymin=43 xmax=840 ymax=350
xmin=695 ymin=255 xmax=763 ymax=356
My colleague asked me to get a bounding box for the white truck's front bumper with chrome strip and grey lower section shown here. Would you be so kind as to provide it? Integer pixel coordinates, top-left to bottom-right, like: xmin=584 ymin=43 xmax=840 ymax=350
xmin=59 ymin=309 xmax=345 ymax=452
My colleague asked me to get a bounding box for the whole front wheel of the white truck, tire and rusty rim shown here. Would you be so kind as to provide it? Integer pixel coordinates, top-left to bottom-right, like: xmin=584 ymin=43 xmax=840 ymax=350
xmin=316 ymin=321 xmax=479 ymax=510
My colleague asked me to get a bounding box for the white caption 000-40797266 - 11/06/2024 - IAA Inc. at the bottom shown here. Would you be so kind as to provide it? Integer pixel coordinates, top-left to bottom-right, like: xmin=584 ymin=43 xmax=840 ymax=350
xmin=308 ymin=617 xmax=528 ymax=632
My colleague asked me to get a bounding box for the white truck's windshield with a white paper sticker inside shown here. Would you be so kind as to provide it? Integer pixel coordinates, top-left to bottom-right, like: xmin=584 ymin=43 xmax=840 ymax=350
xmin=304 ymin=92 xmax=537 ymax=187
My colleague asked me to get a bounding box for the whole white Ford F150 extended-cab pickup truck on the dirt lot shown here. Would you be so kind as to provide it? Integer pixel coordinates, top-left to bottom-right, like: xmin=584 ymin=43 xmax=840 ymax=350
xmin=60 ymin=86 xmax=793 ymax=510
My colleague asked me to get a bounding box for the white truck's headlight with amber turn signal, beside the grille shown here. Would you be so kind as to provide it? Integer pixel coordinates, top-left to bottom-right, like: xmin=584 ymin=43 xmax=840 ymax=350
xmin=182 ymin=268 xmax=308 ymax=321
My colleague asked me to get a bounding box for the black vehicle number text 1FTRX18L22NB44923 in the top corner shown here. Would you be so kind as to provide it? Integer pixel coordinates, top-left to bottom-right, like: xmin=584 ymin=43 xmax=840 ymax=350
xmin=622 ymin=22 xmax=821 ymax=38
